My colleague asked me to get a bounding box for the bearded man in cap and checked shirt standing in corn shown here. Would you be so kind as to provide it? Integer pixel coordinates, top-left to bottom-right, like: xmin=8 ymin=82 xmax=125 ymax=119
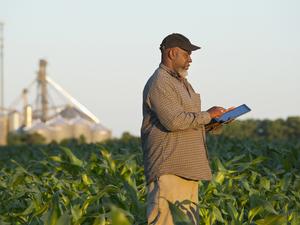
xmin=141 ymin=33 xmax=225 ymax=225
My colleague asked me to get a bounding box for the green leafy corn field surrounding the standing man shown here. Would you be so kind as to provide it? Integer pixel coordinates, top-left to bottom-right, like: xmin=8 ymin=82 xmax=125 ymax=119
xmin=0 ymin=137 xmax=300 ymax=225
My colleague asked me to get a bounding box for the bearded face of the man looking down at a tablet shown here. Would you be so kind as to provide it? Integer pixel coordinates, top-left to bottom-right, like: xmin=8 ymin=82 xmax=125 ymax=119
xmin=173 ymin=47 xmax=192 ymax=77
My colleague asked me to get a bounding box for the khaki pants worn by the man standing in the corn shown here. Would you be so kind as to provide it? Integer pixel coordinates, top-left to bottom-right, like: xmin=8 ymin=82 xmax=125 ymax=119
xmin=147 ymin=174 xmax=199 ymax=225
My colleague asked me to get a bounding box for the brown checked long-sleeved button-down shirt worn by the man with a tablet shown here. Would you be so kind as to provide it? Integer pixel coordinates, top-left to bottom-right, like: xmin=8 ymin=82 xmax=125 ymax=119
xmin=141 ymin=64 xmax=211 ymax=183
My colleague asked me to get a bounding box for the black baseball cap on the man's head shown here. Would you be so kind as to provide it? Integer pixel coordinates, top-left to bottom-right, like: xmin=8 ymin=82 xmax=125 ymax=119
xmin=159 ymin=33 xmax=200 ymax=51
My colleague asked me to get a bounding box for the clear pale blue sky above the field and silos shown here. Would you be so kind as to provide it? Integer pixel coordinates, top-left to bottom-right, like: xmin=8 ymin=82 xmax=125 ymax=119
xmin=0 ymin=0 xmax=300 ymax=136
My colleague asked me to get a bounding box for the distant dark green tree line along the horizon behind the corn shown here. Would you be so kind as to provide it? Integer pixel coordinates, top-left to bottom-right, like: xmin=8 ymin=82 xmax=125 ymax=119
xmin=4 ymin=116 xmax=300 ymax=145
